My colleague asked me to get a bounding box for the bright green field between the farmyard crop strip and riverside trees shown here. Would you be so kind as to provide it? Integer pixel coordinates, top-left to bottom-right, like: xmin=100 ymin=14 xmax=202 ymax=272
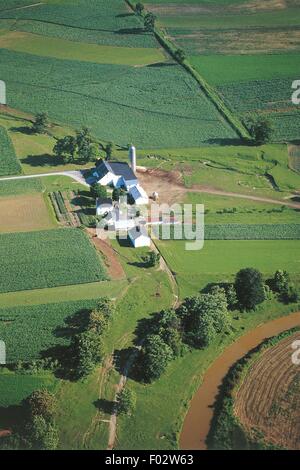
xmin=157 ymin=240 xmax=300 ymax=297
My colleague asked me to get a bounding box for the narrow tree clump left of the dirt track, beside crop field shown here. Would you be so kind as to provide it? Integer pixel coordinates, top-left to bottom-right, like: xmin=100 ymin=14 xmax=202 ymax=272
xmin=71 ymin=298 xmax=114 ymax=378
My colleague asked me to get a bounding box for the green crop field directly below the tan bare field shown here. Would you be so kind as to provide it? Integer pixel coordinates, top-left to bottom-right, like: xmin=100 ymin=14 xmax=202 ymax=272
xmin=0 ymin=229 xmax=105 ymax=292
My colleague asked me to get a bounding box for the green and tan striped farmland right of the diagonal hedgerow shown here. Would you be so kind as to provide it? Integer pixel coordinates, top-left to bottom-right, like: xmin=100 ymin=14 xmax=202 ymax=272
xmin=148 ymin=0 xmax=300 ymax=142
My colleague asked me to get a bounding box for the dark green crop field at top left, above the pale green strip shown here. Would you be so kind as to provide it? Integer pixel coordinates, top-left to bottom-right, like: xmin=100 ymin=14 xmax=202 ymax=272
xmin=0 ymin=0 xmax=156 ymax=47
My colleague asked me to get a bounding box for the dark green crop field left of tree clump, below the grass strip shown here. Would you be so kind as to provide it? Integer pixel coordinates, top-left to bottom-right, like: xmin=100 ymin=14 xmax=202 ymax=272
xmin=0 ymin=300 xmax=97 ymax=362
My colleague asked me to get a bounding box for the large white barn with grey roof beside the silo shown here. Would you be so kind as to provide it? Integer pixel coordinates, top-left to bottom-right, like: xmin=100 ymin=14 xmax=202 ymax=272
xmin=93 ymin=160 xmax=138 ymax=191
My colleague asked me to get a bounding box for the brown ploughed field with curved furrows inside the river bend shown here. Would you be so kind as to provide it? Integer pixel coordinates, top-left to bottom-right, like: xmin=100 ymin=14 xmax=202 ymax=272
xmin=234 ymin=332 xmax=300 ymax=450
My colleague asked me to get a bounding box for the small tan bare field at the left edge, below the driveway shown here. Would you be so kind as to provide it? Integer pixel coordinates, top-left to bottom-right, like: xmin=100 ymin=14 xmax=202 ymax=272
xmin=0 ymin=194 xmax=56 ymax=233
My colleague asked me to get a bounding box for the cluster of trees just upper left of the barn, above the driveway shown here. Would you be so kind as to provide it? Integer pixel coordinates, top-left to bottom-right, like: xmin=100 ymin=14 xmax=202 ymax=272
xmin=53 ymin=127 xmax=100 ymax=163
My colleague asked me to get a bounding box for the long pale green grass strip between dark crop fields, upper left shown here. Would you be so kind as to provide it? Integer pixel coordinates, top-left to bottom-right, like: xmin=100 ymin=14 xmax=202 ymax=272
xmin=0 ymin=31 xmax=166 ymax=66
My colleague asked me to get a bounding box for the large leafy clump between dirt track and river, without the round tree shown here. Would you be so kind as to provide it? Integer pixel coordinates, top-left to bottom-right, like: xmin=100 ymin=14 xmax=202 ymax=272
xmin=138 ymin=287 xmax=231 ymax=382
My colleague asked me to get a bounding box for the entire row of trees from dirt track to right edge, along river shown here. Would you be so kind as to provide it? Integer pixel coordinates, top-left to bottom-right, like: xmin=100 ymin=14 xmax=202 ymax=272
xmin=138 ymin=268 xmax=298 ymax=382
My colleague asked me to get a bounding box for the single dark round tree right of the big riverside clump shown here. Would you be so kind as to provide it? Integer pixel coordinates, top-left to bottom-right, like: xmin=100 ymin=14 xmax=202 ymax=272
xmin=235 ymin=268 xmax=265 ymax=310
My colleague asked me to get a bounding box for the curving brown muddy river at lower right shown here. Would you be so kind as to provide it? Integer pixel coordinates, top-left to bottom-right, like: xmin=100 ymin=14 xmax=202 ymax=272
xmin=179 ymin=312 xmax=300 ymax=450
